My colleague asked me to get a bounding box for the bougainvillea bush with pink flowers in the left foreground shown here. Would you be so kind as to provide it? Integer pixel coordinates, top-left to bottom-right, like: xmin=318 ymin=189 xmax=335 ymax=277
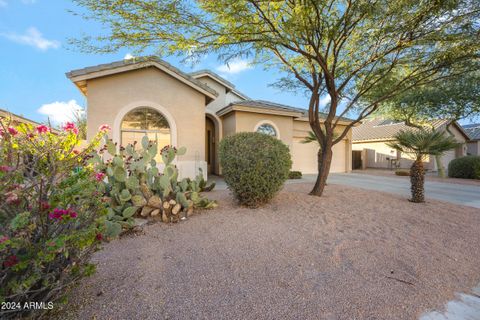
xmin=0 ymin=119 xmax=106 ymax=319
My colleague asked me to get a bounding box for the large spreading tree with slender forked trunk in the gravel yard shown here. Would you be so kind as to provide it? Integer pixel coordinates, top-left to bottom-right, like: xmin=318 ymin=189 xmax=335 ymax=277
xmin=73 ymin=0 xmax=480 ymax=196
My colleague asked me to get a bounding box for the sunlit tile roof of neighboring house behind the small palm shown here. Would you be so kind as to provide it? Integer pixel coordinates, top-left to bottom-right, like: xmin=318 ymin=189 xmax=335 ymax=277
xmin=352 ymin=119 xmax=450 ymax=141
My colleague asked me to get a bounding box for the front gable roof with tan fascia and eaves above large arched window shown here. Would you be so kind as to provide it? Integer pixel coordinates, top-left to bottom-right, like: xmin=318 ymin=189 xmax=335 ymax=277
xmin=66 ymin=57 xmax=218 ymax=100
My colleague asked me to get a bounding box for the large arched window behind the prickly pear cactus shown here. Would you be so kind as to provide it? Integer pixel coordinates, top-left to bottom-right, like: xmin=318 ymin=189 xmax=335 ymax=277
xmin=120 ymin=107 xmax=171 ymax=162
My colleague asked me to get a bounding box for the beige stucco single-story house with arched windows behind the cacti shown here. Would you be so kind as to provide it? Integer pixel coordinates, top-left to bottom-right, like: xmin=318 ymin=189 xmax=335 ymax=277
xmin=67 ymin=58 xmax=352 ymax=176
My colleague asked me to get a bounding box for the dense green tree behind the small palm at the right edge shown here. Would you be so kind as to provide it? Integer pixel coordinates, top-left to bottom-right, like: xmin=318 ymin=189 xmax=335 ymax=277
xmin=375 ymin=71 xmax=480 ymax=177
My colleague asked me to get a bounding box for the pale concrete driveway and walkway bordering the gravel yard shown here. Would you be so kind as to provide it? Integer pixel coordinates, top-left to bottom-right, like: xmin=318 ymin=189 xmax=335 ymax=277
xmin=210 ymin=173 xmax=480 ymax=208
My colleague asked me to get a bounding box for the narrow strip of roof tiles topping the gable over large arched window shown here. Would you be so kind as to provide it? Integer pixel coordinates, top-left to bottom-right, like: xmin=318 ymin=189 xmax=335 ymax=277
xmin=66 ymin=56 xmax=218 ymax=96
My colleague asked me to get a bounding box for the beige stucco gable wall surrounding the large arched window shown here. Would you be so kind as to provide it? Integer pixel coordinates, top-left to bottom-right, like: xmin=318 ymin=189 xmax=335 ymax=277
xmin=87 ymin=68 xmax=206 ymax=176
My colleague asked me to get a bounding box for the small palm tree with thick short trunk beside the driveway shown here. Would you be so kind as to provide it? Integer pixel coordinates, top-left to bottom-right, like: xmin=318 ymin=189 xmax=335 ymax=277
xmin=388 ymin=129 xmax=459 ymax=202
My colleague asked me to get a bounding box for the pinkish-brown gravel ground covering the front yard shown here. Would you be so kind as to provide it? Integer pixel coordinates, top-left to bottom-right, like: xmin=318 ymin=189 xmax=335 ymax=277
xmin=59 ymin=184 xmax=480 ymax=320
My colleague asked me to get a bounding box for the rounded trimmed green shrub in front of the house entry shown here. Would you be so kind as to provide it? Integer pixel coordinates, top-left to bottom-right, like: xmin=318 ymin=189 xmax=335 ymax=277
xmin=219 ymin=132 xmax=292 ymax=208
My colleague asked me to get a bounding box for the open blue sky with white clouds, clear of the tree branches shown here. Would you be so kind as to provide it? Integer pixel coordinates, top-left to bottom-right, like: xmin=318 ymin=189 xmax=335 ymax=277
xmin=0 ymin=0 xmax=314 ymax=121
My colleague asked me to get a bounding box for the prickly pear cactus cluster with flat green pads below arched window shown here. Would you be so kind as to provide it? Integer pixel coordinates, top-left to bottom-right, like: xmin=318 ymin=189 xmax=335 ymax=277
xmin=90 ymin=135 xmax=216 ymax=237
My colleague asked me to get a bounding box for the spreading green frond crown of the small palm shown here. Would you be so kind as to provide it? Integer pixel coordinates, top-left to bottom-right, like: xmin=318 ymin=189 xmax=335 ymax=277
xmin=387 ymin=129 xmax=458 ymax=161
